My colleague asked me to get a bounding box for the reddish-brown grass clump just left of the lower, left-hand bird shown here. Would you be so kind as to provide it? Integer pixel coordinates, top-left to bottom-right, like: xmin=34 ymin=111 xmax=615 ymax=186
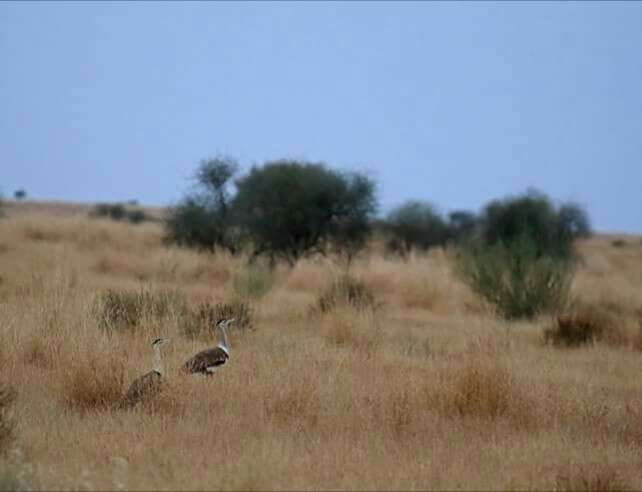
xmin=61 ymin=356 xmax=125 ymax=413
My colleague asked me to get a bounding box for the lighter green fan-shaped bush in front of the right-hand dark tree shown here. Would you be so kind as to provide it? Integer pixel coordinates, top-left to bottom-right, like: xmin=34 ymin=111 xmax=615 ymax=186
xmin=456 ymin=236 xmax=573 ymax=319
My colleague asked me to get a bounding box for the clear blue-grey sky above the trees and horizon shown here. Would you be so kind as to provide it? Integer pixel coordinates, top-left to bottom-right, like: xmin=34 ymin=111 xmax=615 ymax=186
xmin=0 ymin=2 xmax=642 ymax=232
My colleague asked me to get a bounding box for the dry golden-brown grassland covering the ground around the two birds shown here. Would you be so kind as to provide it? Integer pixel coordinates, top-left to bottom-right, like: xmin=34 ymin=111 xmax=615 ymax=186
xmin=0 ymin=206 xmax=642 ymax=490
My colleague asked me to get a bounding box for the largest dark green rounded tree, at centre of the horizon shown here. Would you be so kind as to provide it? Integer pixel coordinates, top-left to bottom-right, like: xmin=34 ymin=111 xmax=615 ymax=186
xmin=233 ymin=160 xmax=376 ymax=265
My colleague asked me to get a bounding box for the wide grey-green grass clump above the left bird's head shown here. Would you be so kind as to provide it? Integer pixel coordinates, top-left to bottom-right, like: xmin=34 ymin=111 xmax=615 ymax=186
xmin=95 ymin=288 xmax=187 ymax=331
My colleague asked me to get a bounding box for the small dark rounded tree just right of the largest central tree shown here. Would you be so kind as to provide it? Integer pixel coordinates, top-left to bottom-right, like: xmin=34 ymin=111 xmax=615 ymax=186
xmin=386 ymin=200 xmax=449 ymax=256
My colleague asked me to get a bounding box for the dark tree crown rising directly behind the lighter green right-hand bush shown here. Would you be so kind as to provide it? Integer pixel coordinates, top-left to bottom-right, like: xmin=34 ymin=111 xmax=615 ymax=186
xmin=481 ymin=190 xmax=590 ymax=258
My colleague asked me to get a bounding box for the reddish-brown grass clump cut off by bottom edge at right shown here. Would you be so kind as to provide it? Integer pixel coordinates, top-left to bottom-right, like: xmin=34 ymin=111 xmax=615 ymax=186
xmin=555 ymin=463 xmax=629 ymax=492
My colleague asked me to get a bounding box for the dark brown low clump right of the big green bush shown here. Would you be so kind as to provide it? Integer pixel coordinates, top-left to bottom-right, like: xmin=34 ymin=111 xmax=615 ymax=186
xmin=544 ymin=303 xmax=626 ymax=347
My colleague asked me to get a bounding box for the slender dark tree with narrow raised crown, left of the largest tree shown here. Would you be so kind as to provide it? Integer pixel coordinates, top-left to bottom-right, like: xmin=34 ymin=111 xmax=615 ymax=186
xmin=165 ymin=157 xmax=240 ymax=253
